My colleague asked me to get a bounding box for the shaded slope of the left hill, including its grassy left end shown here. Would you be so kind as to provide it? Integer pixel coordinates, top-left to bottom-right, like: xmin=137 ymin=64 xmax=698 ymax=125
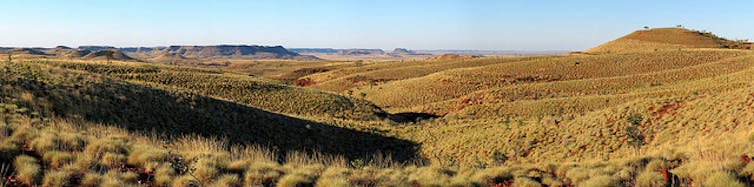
xmin=0 ymin=62 xmax=415 ymax=159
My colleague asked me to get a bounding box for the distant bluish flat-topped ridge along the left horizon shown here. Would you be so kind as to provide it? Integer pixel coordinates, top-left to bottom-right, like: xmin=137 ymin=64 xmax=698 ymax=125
xmin=0 ymin=45 xmax=319 ymax=61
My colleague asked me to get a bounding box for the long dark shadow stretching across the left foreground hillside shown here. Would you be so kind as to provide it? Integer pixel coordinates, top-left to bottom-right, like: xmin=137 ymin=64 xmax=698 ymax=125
xmin=11 ymin=76 xmax=419 ymax=161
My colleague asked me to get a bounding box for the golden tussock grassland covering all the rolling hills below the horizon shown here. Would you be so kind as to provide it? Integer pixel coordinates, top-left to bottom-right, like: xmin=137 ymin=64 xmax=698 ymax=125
xmin=0 ymin=29 xmax=754 ymax=186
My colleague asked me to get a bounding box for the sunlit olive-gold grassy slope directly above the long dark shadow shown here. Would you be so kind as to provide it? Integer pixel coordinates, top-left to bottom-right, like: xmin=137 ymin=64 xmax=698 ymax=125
xmin=45 ymin=62 xmax=386 ymax=120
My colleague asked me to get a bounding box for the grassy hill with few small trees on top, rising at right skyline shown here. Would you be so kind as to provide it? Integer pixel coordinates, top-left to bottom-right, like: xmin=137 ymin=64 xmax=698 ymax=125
xmin=584 ymin=28 xmax=743 ymax=54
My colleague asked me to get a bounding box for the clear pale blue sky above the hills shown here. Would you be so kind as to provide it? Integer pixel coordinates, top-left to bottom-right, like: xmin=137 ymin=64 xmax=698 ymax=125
xmin=0 ymin=0 xmax=754 ymax=50
